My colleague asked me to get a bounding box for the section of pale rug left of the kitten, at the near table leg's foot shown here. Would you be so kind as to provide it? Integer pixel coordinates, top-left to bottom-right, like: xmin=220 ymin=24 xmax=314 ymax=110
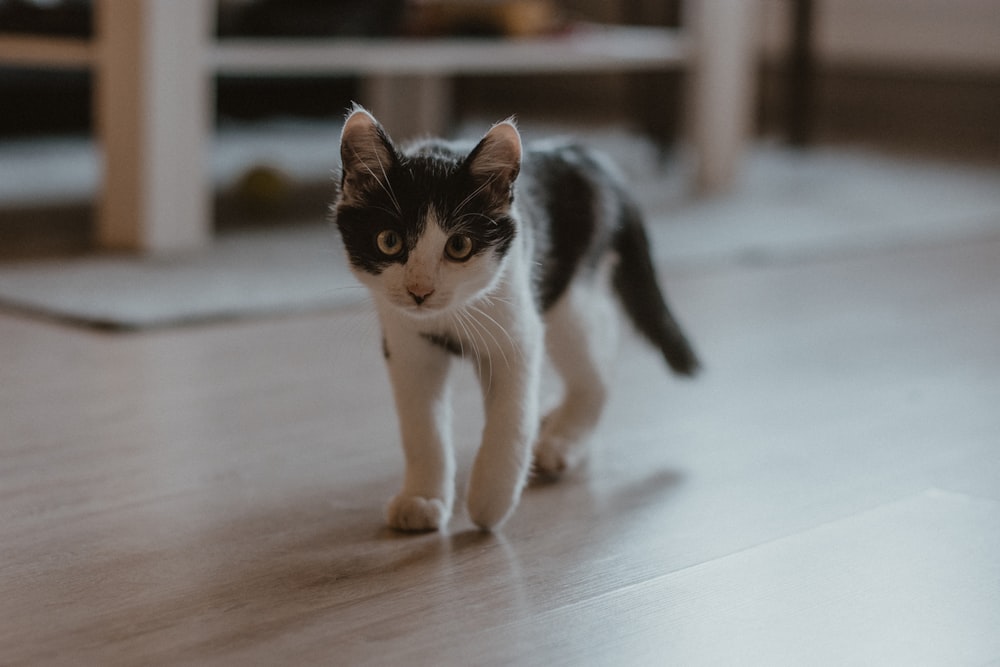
xmin=0 ymin=223 xmax=362 ymax=330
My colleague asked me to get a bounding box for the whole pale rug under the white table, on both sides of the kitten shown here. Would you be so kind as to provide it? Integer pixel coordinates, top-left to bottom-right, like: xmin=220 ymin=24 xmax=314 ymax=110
xmin=0 ymin=124 xmax=1000 ymax=330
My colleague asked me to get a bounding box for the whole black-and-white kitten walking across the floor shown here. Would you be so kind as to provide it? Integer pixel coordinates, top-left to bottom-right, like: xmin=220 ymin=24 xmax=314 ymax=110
xmin=333 ymin=107 xmax=698 ymax=530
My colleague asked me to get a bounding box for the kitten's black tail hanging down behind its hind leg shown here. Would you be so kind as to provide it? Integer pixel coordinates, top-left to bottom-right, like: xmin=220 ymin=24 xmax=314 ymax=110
xmin=613 ymin=201 xmax=700 ymax=377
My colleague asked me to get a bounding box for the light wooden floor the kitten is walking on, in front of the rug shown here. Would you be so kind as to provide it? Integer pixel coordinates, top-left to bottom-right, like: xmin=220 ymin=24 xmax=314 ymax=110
xmin=0 ymin=238 xmax=1000 ymax=666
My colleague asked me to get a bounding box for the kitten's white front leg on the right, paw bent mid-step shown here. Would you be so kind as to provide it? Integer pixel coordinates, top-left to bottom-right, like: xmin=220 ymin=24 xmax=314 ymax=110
xmin=468 ymin=317 xmax=543 ymax=530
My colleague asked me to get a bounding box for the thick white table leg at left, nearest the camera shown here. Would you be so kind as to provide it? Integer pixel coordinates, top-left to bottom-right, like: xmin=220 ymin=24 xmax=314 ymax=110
xmin=95 ymin=0 xmax=214 ymax=252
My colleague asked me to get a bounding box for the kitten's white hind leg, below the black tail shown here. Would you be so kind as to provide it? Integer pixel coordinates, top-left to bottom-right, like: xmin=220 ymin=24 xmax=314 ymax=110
xmin=534 ymin=274 xmax=618 ymax=478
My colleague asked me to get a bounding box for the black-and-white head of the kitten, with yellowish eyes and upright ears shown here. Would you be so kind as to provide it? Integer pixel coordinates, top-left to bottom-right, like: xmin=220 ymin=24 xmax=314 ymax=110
xmin=334 ymin=108 xmax=521 ymax=317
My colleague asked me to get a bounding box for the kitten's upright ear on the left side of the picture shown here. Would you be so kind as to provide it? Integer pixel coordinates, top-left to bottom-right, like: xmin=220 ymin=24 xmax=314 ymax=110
xmin=340 ymin=106 xmax=396 ymax=202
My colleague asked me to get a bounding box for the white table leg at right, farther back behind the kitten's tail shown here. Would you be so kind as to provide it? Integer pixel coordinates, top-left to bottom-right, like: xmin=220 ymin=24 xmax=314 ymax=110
xmin=685 ymin=0 xmax=759 ymax=193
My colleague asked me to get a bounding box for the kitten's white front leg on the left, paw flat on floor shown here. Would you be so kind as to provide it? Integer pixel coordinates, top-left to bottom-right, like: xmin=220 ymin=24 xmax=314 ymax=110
xmin=385 ymin=332 xmax=455 ymax=531
